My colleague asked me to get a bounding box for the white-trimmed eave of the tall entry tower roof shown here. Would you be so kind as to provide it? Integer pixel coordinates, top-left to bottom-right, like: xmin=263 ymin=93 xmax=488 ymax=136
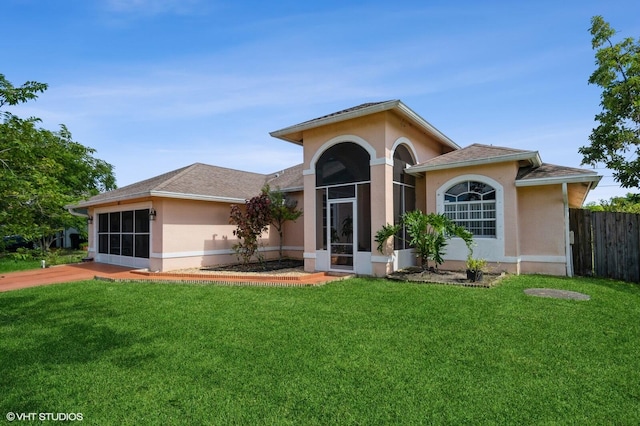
xmin=269 ymin=100 xmax=460 ymax=150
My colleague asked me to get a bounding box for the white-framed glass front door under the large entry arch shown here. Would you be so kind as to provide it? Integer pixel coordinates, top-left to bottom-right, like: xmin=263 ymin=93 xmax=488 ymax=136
xmin=327 ymin=200 xmax=356 ymax=271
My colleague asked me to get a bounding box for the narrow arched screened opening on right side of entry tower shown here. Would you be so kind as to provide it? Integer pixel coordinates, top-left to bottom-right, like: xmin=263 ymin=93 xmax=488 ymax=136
xmin=393 ymin=145 xmax=416 ymax=250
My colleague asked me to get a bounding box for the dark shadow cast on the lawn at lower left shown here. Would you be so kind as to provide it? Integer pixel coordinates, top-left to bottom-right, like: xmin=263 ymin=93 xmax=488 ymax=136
xmin=0 ymin=293 xmax=153 ymax=412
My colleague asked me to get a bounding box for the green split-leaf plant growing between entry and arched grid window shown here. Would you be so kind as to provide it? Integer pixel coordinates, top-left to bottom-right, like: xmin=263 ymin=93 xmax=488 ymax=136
xmin=375 ymin=210 xmax=473 ymax=270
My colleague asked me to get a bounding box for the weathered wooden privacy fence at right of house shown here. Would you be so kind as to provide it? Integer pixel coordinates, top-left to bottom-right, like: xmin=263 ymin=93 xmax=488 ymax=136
xmin=569 ymin=209 xmax=640 ymax=282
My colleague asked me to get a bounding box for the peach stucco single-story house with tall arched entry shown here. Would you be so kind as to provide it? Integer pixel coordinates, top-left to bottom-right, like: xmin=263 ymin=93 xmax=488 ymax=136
xmin=71 ymin=100 xmax=600 ymax=276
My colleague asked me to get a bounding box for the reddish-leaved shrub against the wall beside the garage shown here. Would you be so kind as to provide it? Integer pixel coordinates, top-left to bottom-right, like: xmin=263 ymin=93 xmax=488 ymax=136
xmin=229 ymin=192 xmax=271 ymax=265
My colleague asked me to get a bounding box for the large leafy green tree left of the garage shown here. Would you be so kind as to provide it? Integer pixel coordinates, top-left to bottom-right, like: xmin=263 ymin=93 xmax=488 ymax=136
xmin=0 ymin=74 xmax=115 ymax=250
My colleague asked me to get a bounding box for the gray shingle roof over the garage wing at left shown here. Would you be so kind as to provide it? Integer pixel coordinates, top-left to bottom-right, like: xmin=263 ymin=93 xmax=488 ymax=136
xmin=74 ymin=163 xmax=303 ymax=207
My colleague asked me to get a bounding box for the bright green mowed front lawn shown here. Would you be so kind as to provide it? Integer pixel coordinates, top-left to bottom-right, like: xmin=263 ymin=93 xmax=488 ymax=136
xmin=0 ymin=276 xmax=640 ymax=425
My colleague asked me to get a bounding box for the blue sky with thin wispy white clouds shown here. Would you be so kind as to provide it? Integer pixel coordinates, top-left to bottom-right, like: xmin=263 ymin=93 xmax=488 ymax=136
xmin=5 ymin=0 xmax=640 ymax=201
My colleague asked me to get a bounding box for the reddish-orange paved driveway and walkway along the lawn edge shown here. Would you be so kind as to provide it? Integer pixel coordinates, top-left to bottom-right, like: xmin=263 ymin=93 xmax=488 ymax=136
xmin=0 ymin=262 xmax=346 ymax=292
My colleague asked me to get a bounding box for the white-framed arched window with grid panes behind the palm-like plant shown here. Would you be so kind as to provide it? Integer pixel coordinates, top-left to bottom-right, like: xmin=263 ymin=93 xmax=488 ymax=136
xmin=444 ymin=180 xmax=496 ymax=238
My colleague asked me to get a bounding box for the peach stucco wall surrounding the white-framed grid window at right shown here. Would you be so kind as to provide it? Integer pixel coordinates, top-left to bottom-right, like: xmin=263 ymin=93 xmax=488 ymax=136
xmin=426 ymin=162 xmax=566 ymax=275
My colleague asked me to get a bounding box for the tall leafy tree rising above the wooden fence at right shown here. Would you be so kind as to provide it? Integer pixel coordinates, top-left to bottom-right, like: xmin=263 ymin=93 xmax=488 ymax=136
xmin=579 ymin=16 xmax=640 ymax=188
